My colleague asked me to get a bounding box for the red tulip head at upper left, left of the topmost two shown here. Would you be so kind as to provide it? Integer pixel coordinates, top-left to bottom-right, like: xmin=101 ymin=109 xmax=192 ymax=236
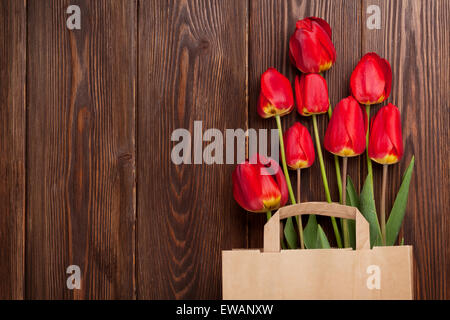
xmin=257 ymin=68 xmax=294 ymax=118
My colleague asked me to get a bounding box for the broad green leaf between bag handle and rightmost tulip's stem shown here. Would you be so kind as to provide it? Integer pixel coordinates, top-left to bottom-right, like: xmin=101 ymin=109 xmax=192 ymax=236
xmin=359 ymin=174 xmax=381 ymax=247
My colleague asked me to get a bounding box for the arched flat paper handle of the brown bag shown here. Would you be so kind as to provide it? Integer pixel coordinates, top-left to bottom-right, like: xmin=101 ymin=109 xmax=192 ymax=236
xmin=264 ymin=202 xmax=370 ymax=252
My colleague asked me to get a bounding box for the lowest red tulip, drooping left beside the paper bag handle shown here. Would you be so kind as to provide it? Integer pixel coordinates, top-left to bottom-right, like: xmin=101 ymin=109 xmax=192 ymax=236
xmin=232 ymin=155 xmax=288 ymax=212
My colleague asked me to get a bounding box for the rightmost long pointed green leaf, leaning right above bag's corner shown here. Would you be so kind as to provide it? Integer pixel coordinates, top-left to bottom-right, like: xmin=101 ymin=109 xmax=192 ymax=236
xmin=386 ymin=156 xmax=414 ymax=246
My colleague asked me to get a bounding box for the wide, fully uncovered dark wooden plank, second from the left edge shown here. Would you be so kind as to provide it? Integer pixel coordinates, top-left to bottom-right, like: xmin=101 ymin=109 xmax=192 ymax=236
xmin=26 ymin=0 xmax=137 ymax=299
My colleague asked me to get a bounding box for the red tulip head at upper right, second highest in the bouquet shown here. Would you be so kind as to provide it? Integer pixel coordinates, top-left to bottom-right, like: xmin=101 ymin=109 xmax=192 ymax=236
xmin=350 ymin=52 xmax=392 ymax=105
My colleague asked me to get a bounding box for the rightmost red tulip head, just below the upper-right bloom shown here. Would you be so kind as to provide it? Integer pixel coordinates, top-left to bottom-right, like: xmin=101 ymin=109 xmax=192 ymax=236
xmin=369 ymin=103 xmax=403 ymax=164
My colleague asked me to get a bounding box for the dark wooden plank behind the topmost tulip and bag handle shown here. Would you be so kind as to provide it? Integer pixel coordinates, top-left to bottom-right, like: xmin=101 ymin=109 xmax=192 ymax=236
xmin=248 ymin=0 xmax=361 ymax=248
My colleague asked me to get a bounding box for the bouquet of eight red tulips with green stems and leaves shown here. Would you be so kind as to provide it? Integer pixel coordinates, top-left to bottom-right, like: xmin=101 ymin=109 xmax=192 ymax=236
xmin=233 ymin=17 xmax=414 ymax=249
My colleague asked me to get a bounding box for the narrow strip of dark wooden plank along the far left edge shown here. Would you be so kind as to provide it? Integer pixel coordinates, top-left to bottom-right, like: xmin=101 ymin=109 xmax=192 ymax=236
xmin=0 ymin=0 xmax=26 ymax=299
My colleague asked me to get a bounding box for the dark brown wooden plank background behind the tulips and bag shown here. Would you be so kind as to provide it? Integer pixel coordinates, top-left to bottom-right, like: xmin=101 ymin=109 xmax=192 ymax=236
xmin=0 ymin=0 xmax=450 ymax=299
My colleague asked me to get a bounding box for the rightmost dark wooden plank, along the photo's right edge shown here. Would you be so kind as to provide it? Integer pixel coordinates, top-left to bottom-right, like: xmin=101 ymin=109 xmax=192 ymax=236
xmin=362 ymin=0 xmax=450 ymax=299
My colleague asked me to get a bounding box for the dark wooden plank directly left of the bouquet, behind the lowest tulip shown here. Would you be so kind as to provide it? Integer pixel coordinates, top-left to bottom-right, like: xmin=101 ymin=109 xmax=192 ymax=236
xmin=137 ymin=0 xmax=247 ymax=299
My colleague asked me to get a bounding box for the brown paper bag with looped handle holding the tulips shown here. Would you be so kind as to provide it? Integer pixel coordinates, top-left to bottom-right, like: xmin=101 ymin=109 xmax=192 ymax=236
xmin=222 ymin=202 xmax=413 ymax=300
